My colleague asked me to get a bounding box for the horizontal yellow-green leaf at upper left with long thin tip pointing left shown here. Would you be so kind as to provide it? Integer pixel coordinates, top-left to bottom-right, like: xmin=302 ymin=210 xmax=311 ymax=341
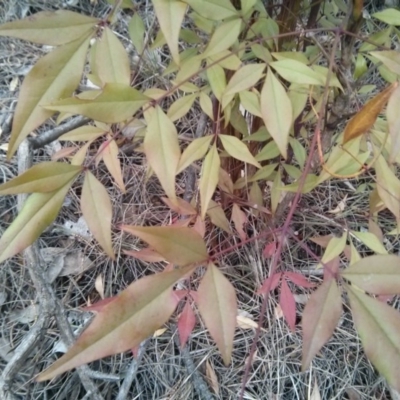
xmin=45 ymin=83 xmax=150 ymax=124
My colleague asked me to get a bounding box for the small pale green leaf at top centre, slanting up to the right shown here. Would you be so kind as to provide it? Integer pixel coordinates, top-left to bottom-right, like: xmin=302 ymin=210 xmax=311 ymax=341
xmin=202 ymin=19 xmax=242 ymax=58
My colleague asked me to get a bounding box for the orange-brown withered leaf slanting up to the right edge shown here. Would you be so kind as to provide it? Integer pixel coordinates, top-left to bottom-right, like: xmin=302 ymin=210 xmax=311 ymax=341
xmin=343 ymin=82 xmax=398 ymax=143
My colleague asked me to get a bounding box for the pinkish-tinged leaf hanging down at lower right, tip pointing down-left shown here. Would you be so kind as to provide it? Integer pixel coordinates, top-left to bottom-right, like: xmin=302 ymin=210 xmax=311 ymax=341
xmin=301 ymin=279 xmax=342 ymax=371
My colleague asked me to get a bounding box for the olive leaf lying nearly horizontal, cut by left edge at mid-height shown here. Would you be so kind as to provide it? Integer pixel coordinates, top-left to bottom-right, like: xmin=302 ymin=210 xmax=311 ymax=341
xmin=0 ymin=161 xmax=82 ymax=195
